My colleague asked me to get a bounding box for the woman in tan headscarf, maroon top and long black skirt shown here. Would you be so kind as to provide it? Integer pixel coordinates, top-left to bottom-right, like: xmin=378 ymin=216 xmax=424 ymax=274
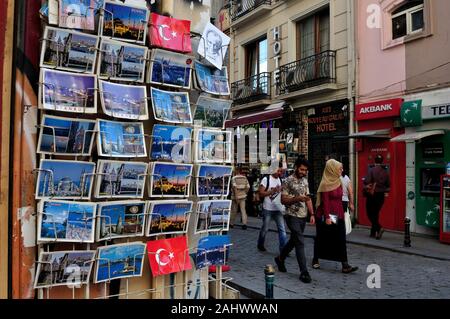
xmin=312 ymin=159 xmax=358 ymax=274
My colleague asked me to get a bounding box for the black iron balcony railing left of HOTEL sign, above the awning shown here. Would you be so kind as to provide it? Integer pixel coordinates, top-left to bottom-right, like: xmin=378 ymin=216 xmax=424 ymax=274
xmin=231 ymin=72 xmax=270 ymax=104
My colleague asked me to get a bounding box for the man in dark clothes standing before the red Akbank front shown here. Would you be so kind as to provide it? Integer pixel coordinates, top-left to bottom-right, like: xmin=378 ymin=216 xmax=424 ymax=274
xmin=364 ymin=154 xmax=391 ymax=239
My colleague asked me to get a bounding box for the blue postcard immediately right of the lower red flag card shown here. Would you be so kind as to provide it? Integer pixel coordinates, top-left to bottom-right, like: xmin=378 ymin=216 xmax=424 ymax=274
xmin=196 ymin=235 xmax=231 ymax=268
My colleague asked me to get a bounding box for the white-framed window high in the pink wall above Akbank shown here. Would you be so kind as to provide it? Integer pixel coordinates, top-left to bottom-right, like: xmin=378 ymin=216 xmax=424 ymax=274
xmin=392 ymin=0 xmax=424 ymax=40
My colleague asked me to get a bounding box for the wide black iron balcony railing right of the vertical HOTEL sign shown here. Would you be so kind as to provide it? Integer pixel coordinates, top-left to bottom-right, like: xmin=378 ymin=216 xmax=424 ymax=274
xmin=279 ymin=51 xmax=336 ymax=94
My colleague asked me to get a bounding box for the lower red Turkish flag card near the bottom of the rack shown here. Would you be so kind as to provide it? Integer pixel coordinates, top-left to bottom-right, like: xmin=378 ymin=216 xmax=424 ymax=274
xmin=147 ymin=236 xmax=192 ymax=277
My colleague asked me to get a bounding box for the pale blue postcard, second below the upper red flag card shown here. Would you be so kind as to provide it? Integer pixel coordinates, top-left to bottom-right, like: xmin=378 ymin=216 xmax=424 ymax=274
xmin=151 ymin=87 xmax=192 ymax=124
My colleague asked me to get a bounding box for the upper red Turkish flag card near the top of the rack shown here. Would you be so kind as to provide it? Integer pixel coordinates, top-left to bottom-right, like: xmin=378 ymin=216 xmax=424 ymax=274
xmin=148 ymin=13 xmax=192 ymax=53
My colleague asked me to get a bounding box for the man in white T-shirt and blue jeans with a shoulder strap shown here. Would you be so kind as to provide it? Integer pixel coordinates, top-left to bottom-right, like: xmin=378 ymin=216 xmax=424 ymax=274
xmin=257 ymin=162 xmax=287 ymax=252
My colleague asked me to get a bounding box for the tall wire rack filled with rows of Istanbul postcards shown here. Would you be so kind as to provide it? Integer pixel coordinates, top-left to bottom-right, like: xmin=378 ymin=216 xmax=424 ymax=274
xmin=34 ymin=0 xmax=232 ymax=299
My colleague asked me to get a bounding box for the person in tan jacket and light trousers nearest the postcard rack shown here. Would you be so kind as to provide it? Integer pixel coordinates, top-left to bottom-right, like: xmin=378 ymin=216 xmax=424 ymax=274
xmin=230 ymin=167 xmax=250 ymax=230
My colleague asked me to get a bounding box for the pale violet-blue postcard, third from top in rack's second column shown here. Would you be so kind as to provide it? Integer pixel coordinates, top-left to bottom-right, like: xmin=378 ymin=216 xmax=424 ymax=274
xmin=99 ymin=80 xmax=148 ymax=120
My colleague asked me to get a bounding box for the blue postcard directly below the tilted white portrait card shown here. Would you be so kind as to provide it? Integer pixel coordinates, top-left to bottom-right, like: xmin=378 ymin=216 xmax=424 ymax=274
xmin=195 ymin=61 xmax=230 ymax=96
